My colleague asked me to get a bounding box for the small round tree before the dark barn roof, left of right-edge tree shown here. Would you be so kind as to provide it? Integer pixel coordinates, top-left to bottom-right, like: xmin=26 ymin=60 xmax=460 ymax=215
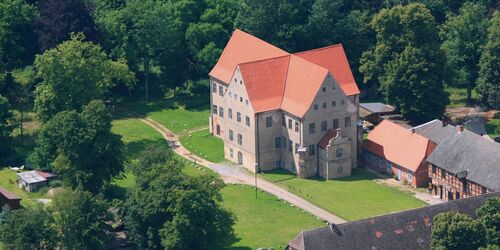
xmin=431 ymin=212 xmax=485 ymax=250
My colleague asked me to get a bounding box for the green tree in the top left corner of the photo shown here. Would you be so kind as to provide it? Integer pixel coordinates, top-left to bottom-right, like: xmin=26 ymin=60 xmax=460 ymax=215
xmin=0 ymin=0 xmax=38 ymax=73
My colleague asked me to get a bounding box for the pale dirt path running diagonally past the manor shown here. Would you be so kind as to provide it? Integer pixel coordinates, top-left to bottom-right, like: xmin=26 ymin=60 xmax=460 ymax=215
xmin=124 ymin=110 xmax=346 ymax=224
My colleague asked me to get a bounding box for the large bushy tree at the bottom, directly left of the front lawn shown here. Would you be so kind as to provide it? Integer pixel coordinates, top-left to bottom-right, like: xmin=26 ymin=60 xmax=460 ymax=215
xmin=124 ymin=149 xmax=234 ymax=249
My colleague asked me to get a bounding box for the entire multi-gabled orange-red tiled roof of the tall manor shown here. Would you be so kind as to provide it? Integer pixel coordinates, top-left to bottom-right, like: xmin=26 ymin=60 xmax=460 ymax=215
xmin=209 ymin=30 xmax=359 ymax=117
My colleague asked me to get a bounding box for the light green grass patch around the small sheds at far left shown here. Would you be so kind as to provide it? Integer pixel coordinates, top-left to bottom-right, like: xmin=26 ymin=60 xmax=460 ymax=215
xmin=0 ymin=167 xmax=48 ymax=206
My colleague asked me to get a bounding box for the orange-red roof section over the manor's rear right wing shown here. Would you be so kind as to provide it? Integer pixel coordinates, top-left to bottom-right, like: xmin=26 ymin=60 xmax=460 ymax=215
xmin=294 ymin=44 xmax=359 ymax=96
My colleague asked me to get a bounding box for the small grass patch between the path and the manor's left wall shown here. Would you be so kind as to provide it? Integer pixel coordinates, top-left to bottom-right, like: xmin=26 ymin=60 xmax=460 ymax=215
xmin=179 ymin=129 xmax=224 ymax=162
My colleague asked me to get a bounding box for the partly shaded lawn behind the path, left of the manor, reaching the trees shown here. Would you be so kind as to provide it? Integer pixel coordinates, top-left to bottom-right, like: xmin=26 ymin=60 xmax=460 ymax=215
xmin=123 ymin=93 xmax=210 ymax=133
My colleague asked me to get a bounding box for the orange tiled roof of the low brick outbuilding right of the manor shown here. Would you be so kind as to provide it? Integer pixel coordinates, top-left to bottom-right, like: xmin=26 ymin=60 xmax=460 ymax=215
xmin=363 ymin=120 xmax=435 ymax=172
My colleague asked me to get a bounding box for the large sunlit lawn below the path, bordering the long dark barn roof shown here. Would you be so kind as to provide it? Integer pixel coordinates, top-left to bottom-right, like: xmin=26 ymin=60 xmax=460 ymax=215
xmin=221 ymin=185 xmax=325 ymax=249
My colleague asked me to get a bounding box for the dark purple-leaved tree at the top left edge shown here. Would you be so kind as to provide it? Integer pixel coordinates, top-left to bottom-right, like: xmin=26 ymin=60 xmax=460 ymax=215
xmin=36 ymin=0 xmax=98 ymax=52
